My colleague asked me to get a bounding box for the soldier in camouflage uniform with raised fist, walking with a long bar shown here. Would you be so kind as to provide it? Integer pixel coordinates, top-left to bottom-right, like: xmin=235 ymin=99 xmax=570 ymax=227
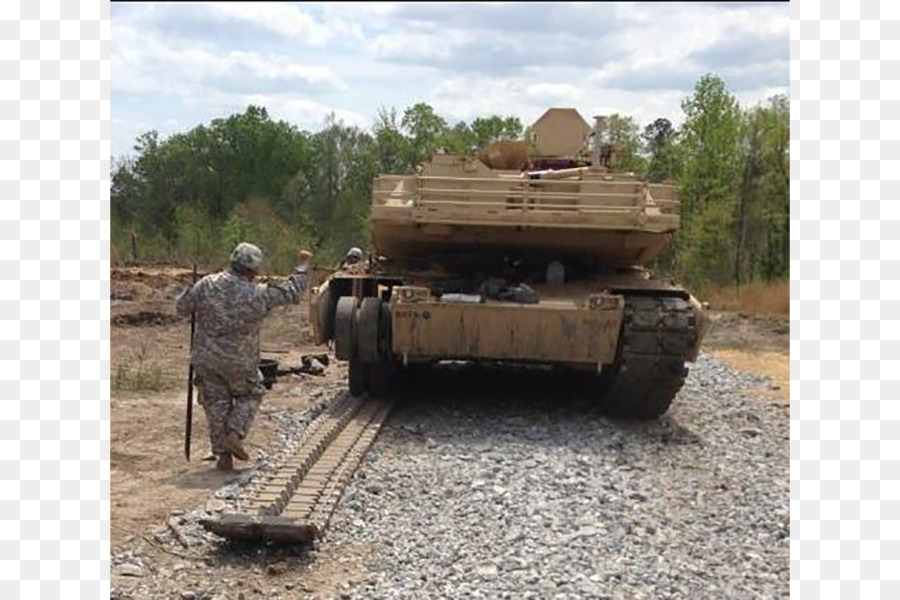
xmin=175 ymin=242 xmax=312 ymax=471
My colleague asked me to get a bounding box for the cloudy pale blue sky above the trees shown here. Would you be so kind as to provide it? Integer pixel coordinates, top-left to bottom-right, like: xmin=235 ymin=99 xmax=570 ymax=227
xmin=111 ymin=2 xmax=790 ymax=156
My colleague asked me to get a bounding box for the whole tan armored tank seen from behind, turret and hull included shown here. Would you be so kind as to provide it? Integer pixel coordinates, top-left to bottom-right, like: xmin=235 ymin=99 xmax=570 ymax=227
xmin=310 ymin=108 xmax=705 ymax=418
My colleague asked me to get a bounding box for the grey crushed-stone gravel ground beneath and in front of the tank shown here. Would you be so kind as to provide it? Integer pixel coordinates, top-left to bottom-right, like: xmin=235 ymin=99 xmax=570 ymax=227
xmin=111 ymin=355 xmax=790 ymax=600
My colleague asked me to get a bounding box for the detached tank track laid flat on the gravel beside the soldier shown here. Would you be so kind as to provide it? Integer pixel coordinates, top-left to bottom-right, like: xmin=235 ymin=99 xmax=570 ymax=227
xmin=201 ymin=394 xmax=391 ymax=542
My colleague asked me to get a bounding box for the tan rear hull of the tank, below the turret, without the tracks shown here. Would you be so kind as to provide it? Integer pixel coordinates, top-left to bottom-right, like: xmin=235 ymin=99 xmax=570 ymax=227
xmin=311 ymin=270 xmax=705 ymax=370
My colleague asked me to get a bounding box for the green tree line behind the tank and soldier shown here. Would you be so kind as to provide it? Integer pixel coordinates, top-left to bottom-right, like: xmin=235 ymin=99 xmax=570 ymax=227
xmin=110 ymin=75 xmax=790 ymax=285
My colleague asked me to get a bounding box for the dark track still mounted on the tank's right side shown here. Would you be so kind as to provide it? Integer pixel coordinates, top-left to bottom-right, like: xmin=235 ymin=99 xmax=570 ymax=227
xmin=605 ymin=295 xmax=699 ymax=419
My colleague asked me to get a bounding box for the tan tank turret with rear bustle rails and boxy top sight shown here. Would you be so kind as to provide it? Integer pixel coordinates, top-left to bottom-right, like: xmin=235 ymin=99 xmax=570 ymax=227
xmin=372 ymin=108 xmax=679 ymax=267
